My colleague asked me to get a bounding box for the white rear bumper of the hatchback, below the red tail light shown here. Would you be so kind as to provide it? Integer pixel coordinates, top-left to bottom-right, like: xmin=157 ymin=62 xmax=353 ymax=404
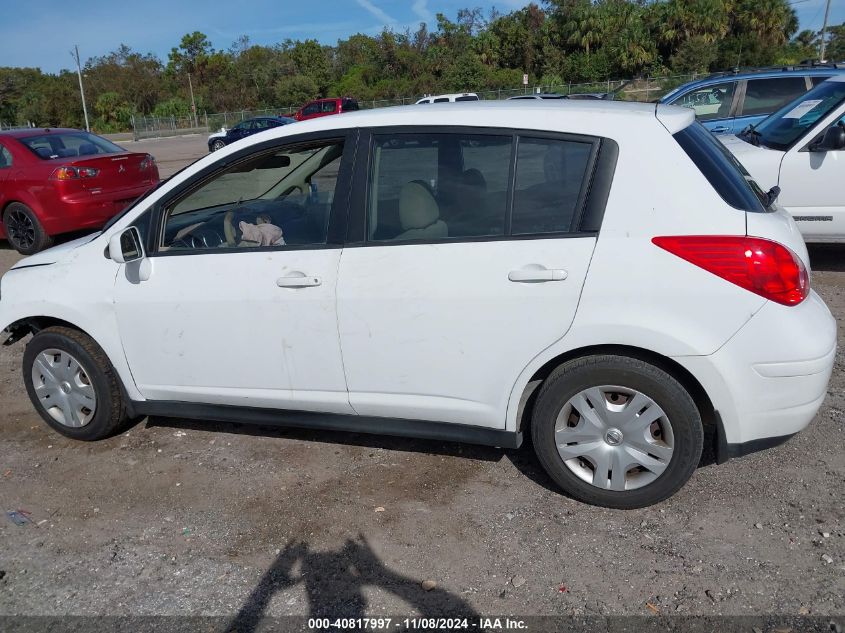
xmin=675 ymin=292 xmax=836 ymax=450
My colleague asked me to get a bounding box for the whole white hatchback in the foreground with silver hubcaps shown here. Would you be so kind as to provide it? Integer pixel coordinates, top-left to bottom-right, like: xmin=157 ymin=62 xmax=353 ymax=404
xmin=0 ymin=101 xmax=836 ymax=508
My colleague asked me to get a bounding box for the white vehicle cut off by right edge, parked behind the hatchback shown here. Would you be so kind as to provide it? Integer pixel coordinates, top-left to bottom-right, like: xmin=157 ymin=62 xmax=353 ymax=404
xmin=717 ymin=74 xmax=845 ymax=242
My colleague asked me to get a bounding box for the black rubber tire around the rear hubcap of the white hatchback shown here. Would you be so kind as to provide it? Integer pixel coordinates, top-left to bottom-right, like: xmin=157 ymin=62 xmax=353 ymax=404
xmin=531 ymin=355 xmax=704 ymax=509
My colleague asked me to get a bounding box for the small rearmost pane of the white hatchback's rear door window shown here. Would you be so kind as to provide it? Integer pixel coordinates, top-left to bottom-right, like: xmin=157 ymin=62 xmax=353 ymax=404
xmin=511 ymin=137 xmax=593 ymax=235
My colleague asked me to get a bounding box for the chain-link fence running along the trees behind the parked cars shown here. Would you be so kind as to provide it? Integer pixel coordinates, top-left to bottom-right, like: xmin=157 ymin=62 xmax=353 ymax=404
xmin=132 ymin=74 xmax=704 ymax=141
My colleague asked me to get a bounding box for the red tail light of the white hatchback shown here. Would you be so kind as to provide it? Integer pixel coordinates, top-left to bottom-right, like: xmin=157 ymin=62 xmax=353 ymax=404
xmin=651 ymin=235 xmax=810 ymax=306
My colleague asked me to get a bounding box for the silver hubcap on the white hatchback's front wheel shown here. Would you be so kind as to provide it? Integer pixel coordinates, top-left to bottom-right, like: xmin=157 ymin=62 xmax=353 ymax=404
xmin=32 ymin=349 xmax=97 ymax=428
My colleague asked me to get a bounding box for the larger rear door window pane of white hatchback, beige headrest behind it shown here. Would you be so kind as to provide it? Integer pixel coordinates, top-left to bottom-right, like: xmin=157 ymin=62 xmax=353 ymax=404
xmin=368 ymin=134 xmax=512 ymax=241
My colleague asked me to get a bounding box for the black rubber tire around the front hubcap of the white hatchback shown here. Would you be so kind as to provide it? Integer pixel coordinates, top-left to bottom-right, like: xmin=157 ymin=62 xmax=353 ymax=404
xmin=23 ymin=327 xmax=128 ymax=441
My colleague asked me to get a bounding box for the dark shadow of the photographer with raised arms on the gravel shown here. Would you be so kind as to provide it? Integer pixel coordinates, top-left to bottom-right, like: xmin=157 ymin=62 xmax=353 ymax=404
xmin=227 ymin=535 xmax=478 ymax=633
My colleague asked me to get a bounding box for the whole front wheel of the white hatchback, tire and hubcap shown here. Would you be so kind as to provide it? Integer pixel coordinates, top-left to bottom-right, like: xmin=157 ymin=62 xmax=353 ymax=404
xmin=23 ymin=327 xmax=128 ymax=440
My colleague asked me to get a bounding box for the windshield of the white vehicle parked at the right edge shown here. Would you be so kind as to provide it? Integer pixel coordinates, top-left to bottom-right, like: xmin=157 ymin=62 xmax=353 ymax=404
xmin=752 ymin=81 xmax=845 ymax=150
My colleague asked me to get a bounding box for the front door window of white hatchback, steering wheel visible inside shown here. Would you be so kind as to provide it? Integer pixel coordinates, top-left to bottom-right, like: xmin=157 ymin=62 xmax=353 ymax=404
xmin=159 ymin=142 xmax=343 ymax=251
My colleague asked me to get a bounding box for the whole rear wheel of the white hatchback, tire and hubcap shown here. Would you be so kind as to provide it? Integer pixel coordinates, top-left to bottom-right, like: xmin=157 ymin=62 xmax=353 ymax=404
xmin=531 ymin=355 xmax=703 ymax=509
